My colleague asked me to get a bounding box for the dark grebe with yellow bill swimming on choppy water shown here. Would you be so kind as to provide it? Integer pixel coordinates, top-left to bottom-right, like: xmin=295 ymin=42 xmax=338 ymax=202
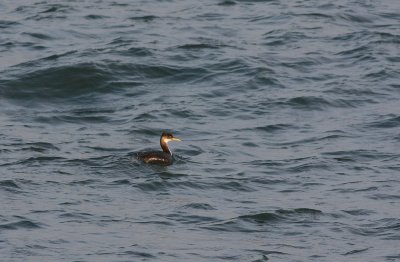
xmin=138 ymin=133 xmax=181 ymax=166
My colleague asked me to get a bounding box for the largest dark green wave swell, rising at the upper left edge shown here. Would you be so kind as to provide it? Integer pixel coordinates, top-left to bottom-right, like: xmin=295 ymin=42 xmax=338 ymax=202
xmin=0 ymin=60 xmax=209 ymax=104
